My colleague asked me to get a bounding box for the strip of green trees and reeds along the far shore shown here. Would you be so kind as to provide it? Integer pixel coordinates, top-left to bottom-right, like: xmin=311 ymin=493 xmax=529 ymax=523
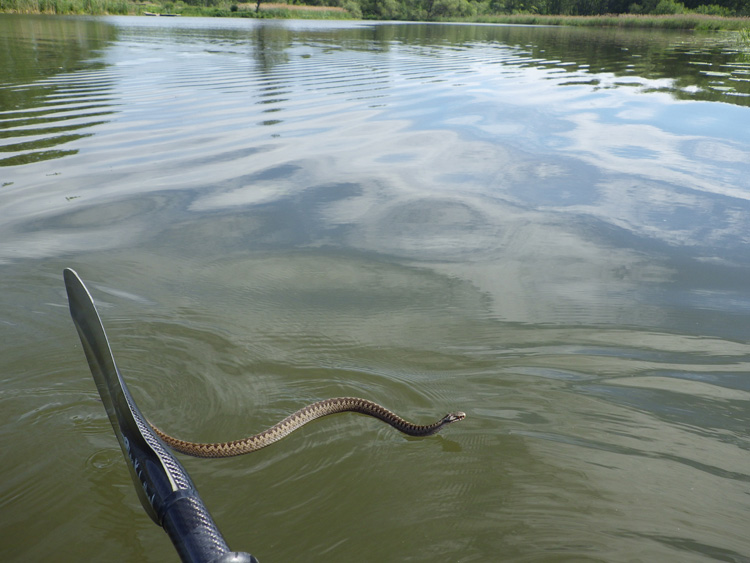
xmin=0 ymin=0 xmax=750 ymax=30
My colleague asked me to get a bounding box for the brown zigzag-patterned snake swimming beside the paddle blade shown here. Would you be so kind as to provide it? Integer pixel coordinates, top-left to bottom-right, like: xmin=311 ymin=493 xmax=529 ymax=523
xmin=149 ymin=397 xmax=466 ymax=458
